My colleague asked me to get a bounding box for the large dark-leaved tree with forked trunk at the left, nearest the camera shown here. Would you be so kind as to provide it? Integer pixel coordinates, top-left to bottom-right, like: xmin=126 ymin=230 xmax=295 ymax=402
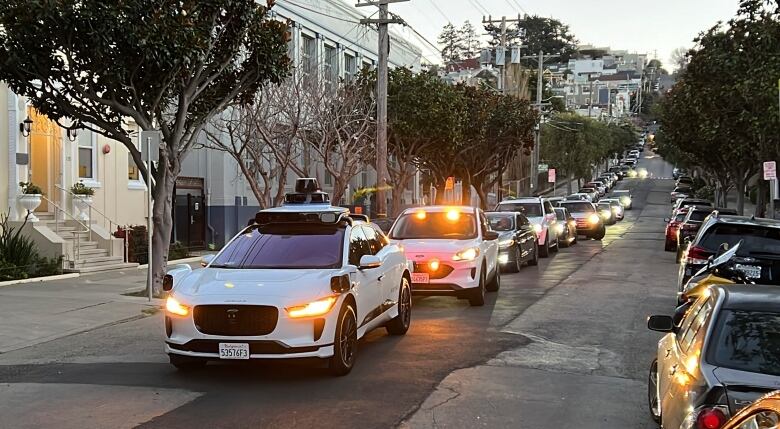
xmin=0 ymin=0 xmax=289 ymax=291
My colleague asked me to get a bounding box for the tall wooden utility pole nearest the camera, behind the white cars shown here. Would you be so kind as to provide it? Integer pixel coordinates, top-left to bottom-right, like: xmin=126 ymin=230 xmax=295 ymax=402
xmin=355 ymin=0 xmax=409 ymax=217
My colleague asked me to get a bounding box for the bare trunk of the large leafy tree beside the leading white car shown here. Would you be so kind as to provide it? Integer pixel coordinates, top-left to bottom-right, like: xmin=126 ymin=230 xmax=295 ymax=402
xmin=149 ymin=169 xmax=176 ymax=296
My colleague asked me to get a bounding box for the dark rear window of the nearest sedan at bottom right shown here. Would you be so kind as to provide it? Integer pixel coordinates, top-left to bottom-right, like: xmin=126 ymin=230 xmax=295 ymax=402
xmin=709 ymin=310 xmax=780 ymax=375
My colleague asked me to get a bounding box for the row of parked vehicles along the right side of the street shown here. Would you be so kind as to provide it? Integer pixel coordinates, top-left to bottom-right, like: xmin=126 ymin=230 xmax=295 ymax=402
xmin=647 ymin=176 xmax=780 ymax=429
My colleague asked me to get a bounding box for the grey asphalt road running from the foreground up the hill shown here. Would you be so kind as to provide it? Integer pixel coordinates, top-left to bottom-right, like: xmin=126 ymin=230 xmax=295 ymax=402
xmin=0 ymin=152 xmax=675 ymax=429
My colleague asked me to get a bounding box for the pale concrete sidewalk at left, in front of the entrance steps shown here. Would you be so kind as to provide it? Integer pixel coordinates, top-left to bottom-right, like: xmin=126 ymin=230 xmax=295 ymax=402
xmin=0 ymin=268 xmax=161 ymax=354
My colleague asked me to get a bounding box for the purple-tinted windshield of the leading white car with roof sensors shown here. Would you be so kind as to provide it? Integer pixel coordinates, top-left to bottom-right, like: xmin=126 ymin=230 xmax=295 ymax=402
xmin=210 ymin=225 xmax=344 ymax=269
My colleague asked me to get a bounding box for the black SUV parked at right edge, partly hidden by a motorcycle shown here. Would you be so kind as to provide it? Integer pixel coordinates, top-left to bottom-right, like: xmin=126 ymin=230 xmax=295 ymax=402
xmin=677 ymin=212 xmax=780 ymax=292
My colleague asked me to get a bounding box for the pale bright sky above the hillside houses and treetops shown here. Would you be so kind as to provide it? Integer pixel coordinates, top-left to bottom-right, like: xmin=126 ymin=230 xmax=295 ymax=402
xmin=378 ymin=0 xmax=738 ymax=69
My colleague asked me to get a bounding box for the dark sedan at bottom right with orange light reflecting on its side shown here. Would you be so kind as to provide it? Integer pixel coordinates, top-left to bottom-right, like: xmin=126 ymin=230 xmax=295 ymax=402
xmin=647 ymin=285 xmax=780 ymax=428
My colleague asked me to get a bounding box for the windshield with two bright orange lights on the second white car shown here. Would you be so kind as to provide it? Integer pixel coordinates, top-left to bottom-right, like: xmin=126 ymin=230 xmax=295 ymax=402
xmin=390 ymin=211 xmax=477 ymax=240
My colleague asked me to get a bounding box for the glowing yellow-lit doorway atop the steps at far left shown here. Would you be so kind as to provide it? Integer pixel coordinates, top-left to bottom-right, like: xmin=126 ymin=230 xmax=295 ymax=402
xmin=27 ymin=107 xmax=62 ymax=212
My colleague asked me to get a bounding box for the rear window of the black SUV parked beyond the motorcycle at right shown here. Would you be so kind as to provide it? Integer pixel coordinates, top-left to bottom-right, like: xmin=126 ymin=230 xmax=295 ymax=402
xmin=699 ymin=223 xmax=780 ymax=256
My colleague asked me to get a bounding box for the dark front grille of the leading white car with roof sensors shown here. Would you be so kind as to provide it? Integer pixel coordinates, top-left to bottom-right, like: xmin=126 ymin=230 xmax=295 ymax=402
xmin=192 ymin=305 xmax=279 ymax=336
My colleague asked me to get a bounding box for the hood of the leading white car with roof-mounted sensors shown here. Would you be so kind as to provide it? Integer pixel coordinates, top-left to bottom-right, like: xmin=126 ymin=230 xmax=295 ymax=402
xmin=174 ymin=268 xmax=334 ymax=299
